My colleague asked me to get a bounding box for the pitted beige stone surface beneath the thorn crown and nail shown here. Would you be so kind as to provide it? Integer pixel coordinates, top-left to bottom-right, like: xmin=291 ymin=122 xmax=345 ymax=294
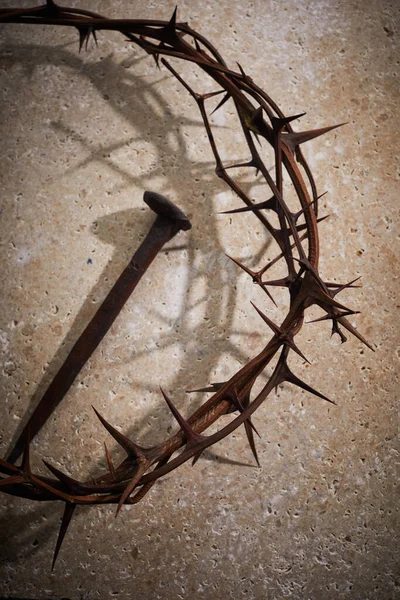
xmin=0 ymin=0 xmax=400 ymax=600
